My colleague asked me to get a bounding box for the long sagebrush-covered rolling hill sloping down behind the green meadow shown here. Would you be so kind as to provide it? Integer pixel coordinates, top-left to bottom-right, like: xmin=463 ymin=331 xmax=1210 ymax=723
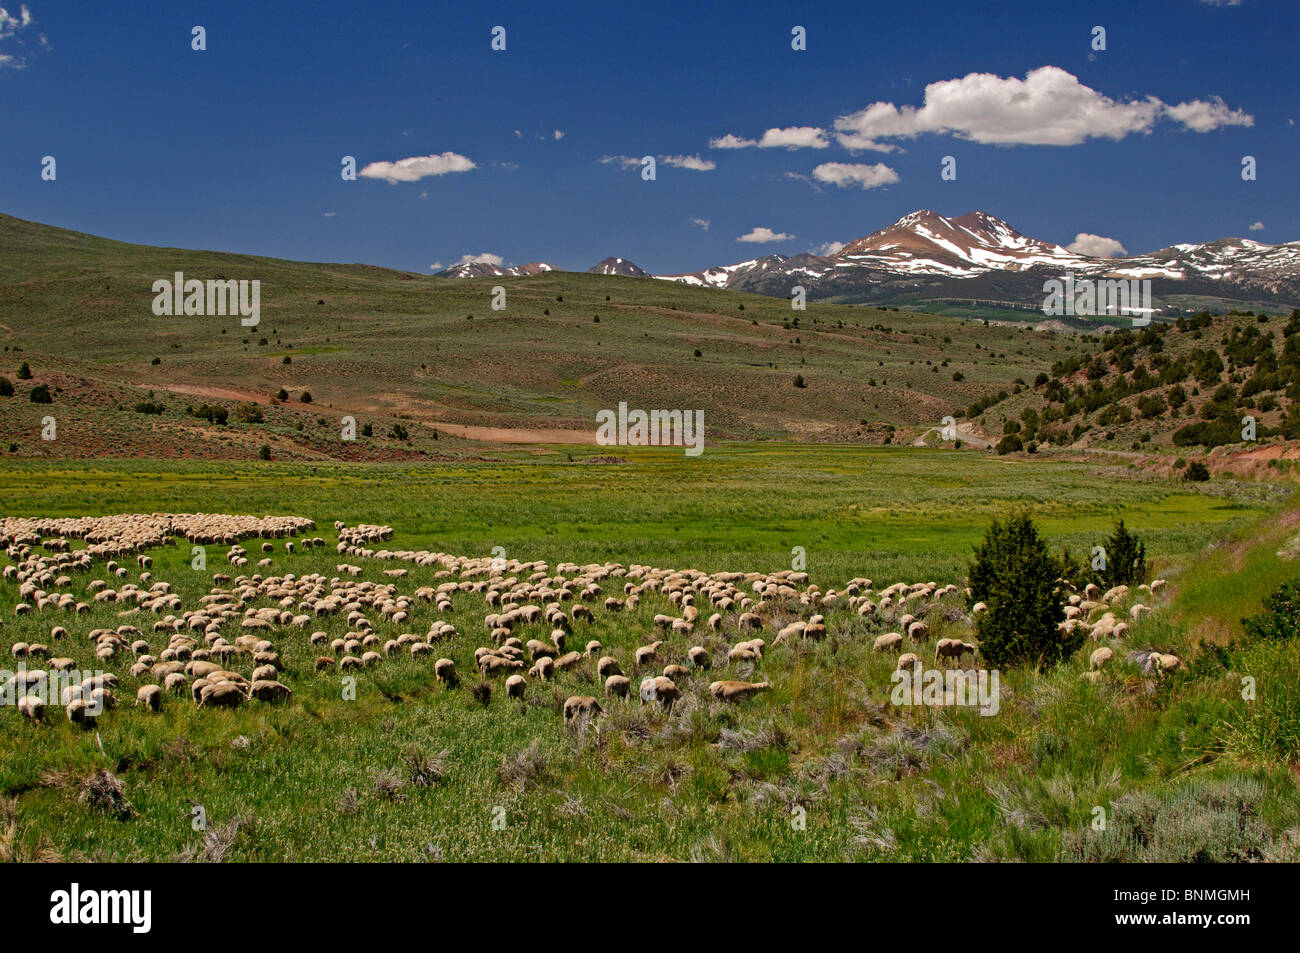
xmin=0 ymin=216 xmax=1088 ymax=460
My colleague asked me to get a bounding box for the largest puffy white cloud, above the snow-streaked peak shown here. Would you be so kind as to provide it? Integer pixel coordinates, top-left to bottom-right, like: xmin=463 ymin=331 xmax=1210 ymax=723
xmin=835 ymin=66 xmax=1253 ymax=152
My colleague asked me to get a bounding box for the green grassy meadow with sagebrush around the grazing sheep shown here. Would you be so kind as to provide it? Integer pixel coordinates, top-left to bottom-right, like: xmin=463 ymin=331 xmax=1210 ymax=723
xmin=0 ymin=443 xmax=1300 ymax=861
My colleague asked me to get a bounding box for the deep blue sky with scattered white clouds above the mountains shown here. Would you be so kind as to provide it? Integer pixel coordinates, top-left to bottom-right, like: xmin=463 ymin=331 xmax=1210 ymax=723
xmin=0 ymin=0 xmax=1300 ymax=273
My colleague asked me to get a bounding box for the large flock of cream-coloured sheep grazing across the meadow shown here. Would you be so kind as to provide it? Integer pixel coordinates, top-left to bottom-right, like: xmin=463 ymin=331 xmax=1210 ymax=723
xmin=0 ymin=514 xmax=1179 ymax=724
